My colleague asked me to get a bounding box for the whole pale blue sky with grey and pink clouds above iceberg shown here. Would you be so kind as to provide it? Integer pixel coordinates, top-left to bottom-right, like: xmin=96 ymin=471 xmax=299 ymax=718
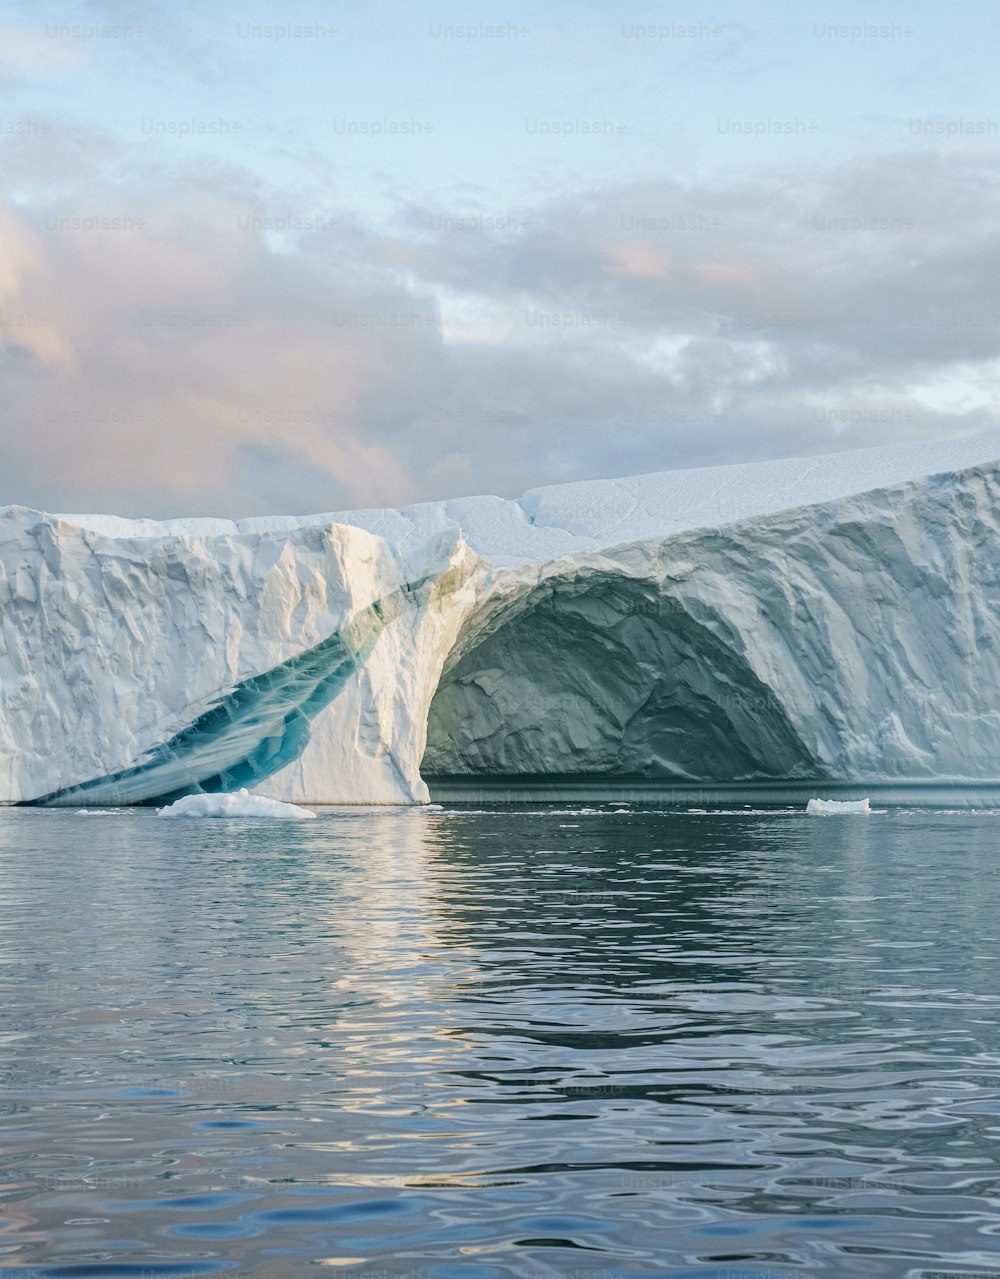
xmin=0 ymin=0 xmax=1000 ymax=518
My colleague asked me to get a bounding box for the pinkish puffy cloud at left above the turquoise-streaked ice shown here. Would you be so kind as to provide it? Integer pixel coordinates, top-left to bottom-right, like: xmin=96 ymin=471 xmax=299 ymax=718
xmin=0 ymin=191 xmax=434 ymax=512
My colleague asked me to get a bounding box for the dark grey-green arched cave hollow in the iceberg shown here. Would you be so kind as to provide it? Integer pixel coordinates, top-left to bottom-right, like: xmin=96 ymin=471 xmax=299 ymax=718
xmin=422 ymin=572 xmax=822 ymax=781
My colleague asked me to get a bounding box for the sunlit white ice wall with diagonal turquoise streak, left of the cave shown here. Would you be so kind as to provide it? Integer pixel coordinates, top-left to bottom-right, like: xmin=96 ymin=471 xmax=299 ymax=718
xmin=0 ymin=508 xmax=478 ymax=804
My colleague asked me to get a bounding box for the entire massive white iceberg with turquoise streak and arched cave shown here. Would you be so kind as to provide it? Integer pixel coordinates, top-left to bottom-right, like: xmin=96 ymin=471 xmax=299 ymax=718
xmin=0 ymin=434 xmax=1000 ymax=807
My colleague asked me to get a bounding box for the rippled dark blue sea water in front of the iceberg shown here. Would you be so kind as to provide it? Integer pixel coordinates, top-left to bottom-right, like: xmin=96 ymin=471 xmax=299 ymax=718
xmin=0 ymin=806 xmax=1000 ymax=1279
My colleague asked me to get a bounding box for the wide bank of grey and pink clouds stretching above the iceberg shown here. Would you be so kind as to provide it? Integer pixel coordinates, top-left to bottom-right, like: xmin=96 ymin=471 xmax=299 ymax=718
xmin=0 ymin=145 xmax=1000 ymax=515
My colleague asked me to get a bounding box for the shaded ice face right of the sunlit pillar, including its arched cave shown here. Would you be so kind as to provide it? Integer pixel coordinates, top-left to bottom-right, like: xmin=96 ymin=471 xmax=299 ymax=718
xmin=423 ymin=467 xmax=1000 ymax=781
